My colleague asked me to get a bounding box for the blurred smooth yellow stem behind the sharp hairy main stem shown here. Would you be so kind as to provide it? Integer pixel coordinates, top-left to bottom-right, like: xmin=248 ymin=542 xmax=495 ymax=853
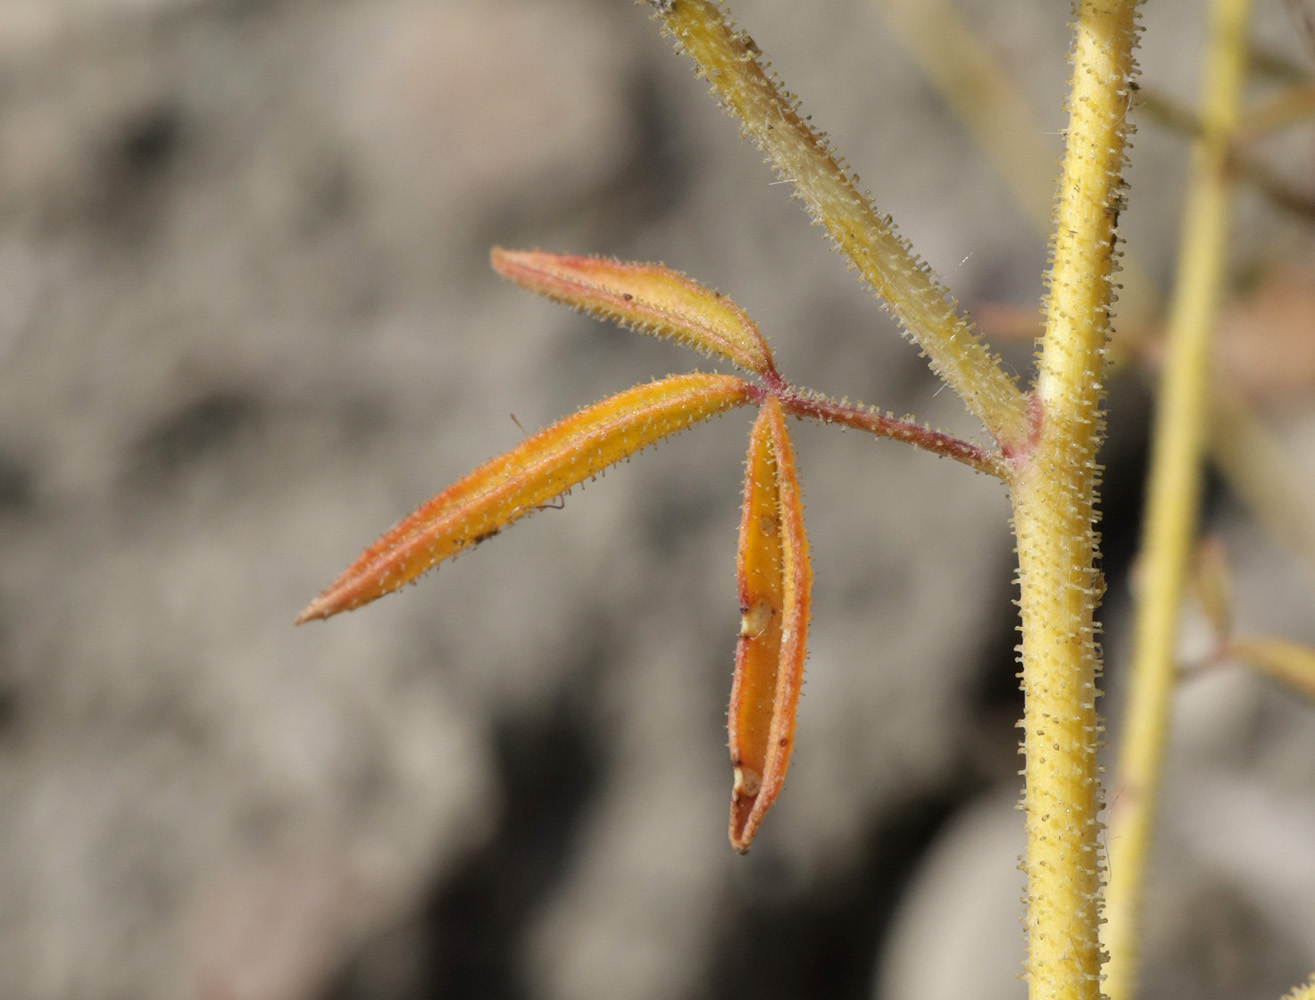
xmin=1105 ymin=0 xmax=1249 ymax=1000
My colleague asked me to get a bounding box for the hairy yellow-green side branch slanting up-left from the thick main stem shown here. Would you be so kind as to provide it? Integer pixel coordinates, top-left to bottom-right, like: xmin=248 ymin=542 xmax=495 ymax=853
xmin=652 ymin=0 xmax=1030 ymax=451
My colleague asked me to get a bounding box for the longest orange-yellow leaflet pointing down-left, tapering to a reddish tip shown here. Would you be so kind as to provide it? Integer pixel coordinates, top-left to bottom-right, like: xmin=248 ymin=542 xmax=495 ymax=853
xmin=297 ymin=372 xmax=753 ymax=624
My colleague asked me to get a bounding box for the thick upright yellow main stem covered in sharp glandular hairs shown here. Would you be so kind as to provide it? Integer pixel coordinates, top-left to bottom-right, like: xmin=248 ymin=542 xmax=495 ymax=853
xmin=1014 ymin=0 xmax=1136 ymax=1000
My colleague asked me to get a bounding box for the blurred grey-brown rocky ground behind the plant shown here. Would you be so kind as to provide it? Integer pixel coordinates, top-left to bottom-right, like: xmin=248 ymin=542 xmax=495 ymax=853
xmin=0 ymin=0 xmax=1315 ymax=1000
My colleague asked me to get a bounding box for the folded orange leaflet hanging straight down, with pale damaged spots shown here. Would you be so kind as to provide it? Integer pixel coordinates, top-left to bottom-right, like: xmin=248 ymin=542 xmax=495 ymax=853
xmin=727 ymin=396 xmax=811 ymax=854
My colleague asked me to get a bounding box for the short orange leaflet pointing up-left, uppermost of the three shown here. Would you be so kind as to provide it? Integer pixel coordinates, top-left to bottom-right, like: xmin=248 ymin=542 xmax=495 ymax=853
xmin=490 ymin=246 xmax=776 ymax=376
